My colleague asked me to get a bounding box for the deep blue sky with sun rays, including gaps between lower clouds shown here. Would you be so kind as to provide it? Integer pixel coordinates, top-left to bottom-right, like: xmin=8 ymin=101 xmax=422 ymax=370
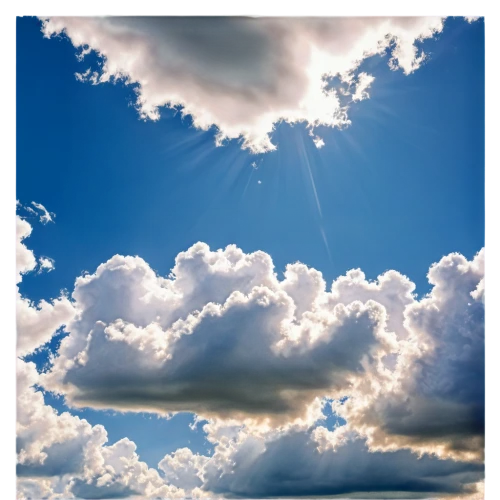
xmin=13 ymin=12 xmax=487 ymax=500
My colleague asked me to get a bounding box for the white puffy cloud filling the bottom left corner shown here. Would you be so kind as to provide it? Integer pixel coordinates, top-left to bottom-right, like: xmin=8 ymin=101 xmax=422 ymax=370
xmin=16 ymin=360 xmax=185 ymax=500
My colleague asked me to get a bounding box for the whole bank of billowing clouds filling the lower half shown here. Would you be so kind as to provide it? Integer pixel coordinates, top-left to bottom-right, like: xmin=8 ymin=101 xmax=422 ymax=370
xmin=16 ymin=204 xmax=487 ymax=500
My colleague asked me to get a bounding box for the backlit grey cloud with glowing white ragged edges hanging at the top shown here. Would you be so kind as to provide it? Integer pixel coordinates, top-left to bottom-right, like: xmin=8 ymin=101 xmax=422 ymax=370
xmin=38 ymin=9 xmax=443 ymax=153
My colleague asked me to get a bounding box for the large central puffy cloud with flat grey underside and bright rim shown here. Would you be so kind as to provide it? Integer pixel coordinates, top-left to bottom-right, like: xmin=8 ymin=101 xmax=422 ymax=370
xmin=44 ymin=244 xmax=397 ymax=420
